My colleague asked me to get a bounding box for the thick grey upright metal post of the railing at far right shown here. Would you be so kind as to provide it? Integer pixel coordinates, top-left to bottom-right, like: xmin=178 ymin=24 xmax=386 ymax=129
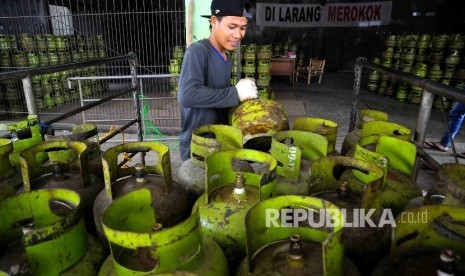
xmin=413 ymin=89 xmax=434 ymax=181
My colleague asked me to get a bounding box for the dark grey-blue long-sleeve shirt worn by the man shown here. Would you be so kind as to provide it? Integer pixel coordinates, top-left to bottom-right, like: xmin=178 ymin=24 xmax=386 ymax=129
xmin=178 ymin=39 xmax=239 ymax=161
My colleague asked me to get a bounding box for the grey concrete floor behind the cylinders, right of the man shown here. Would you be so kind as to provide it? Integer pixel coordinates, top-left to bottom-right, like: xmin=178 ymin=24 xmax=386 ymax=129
xmin=271 ymin=72 xmax=465 ymax=190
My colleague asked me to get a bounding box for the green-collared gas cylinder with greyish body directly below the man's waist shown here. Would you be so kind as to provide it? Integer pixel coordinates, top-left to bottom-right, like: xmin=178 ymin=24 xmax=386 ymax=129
xmin=178 ymin=125 xmax=242 ymax=199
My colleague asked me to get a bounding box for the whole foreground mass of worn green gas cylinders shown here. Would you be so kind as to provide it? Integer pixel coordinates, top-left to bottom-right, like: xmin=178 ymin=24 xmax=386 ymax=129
xmin=0 ymin=99 xmax=465 ymax=276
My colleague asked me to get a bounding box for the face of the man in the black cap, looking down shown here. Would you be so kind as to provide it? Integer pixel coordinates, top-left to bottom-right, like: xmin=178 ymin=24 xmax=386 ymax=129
xmin=211 ymin=16 xmax=247 ymax=52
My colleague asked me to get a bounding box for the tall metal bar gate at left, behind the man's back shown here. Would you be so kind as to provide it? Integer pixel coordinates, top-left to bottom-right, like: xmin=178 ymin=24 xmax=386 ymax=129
xmin=0 ymin=0 xmax=185 ymax=133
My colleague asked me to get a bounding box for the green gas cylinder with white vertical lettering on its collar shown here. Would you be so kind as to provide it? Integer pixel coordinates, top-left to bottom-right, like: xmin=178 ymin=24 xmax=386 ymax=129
xmin=269 ymin=130 xmax=328 ymax=197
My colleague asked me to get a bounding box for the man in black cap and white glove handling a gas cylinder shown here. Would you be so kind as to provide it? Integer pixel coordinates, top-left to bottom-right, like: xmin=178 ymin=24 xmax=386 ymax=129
xmin=178 ymin=0 xmax=257 ymax=161
